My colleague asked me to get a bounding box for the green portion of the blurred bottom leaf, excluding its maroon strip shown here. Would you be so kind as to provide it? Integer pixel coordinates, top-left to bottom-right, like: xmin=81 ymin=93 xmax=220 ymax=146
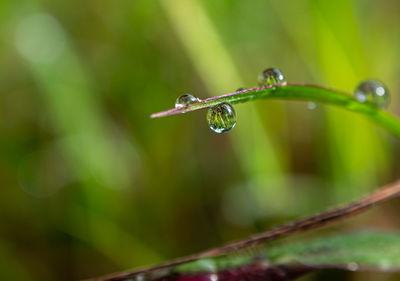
xmin=122 ymin=231 xmax=400 ymax=280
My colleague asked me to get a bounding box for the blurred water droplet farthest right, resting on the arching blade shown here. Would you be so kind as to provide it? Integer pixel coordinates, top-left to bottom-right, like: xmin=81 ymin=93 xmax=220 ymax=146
xmin=354 ymin=79 xmax=390 ymax=108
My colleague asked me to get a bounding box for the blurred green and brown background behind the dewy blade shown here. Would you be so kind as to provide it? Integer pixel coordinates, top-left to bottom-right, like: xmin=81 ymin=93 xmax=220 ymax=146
xmin=0 ymin=0 xmax=400 ymax=281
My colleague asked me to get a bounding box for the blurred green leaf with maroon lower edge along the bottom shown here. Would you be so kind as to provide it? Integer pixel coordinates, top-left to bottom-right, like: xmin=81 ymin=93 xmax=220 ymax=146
xmin=93 ymin=231 xmax=400 ymax=281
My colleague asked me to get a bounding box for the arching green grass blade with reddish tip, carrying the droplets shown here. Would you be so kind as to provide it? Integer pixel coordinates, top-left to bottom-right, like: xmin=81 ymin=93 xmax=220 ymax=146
xmin=150 ymin=84 xmax=400 ymax=138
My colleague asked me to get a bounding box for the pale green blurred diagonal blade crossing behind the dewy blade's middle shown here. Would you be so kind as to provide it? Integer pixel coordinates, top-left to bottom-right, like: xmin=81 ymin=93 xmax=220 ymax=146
xmin=162 ymin=0 xmax=291 ymax=228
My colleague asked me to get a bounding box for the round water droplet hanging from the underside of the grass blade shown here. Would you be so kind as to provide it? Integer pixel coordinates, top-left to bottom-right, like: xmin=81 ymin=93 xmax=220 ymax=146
xmin=207 ymin=102 xmax=236 ymax=134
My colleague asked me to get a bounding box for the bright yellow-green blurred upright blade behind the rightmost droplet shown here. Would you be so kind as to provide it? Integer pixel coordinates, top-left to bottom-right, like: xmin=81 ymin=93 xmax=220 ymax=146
xmin=314 ymin=1 xmax=390 ymax=200
